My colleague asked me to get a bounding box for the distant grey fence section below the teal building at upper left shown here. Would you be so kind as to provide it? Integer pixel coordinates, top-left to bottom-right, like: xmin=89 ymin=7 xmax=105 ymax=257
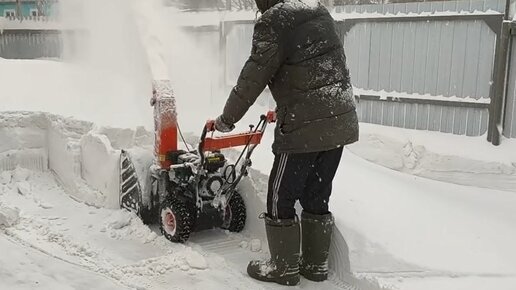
xmin=0 ymin=30 xmax=62 ymax=59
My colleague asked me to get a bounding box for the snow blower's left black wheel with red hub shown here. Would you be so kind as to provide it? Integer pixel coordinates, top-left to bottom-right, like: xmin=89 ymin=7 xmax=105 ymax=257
xmin=159 ymin=196 xmax=194 ymax=243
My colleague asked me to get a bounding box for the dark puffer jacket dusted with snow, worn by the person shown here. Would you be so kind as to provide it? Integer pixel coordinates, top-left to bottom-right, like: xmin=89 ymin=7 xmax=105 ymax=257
xmin=222 ymin=0 xmax=358 ymax=153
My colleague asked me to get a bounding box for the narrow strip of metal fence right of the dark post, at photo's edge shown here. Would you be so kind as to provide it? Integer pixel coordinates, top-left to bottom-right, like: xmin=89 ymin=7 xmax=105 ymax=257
xmin=504 ymin=36 xmax=516 ymax=138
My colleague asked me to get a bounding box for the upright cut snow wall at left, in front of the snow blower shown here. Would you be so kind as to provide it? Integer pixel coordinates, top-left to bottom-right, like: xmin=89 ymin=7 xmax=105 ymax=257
xmin=0 ymin=112 xmax=153 ymax=208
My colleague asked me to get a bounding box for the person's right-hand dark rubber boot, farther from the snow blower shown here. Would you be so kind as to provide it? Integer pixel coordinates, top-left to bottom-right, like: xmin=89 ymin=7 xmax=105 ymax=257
xmin=299 ymin=211 xmax=335 ymax=282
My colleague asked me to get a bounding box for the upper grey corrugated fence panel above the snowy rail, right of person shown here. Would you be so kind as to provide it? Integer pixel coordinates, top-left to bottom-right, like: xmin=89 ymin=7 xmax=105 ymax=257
xmin=343 ymin=21 xmax=496 ymax=99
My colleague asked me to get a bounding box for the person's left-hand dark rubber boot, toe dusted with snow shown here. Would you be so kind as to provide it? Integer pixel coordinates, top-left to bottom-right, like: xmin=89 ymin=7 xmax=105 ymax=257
xmin=247 ymin=216 xmax=300 ymax=286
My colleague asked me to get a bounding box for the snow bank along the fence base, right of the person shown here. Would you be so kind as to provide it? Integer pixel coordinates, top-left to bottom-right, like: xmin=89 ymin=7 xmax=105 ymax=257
xmin=349 ymin=124 xmax=516 ymax=191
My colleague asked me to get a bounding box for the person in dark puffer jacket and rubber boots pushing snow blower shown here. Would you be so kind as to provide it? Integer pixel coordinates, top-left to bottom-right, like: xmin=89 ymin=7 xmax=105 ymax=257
xmin=215 ymin=0 xmax=358 ymax=285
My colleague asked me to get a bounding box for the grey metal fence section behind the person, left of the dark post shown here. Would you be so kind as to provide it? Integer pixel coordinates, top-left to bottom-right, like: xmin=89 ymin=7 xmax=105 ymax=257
xmin=224 ymin=11 xmax=502 ymax=136
